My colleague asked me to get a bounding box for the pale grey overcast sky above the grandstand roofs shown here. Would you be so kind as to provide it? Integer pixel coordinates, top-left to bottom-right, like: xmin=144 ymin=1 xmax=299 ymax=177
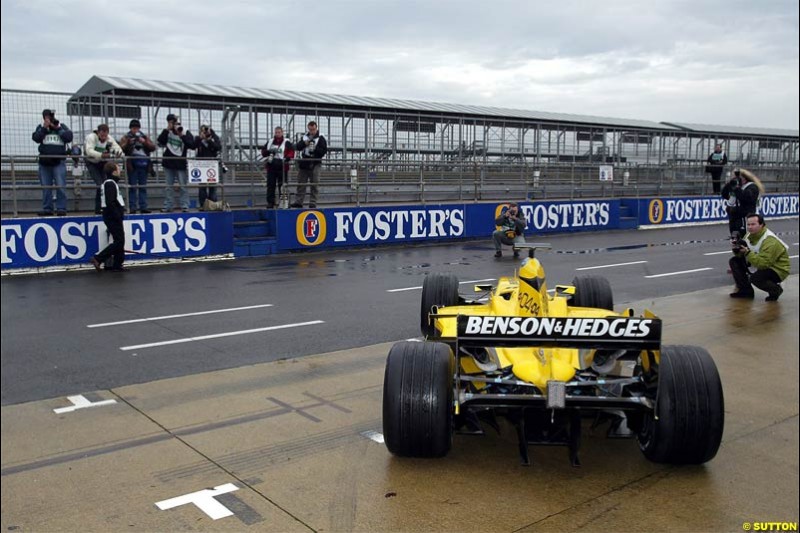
xmin=1 ymin=0 xmax=799 ymax=130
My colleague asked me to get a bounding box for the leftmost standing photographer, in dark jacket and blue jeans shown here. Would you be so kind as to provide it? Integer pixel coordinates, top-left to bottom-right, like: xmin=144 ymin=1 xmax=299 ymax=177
xmin=31 ymin=109 xmax=72 ymax=217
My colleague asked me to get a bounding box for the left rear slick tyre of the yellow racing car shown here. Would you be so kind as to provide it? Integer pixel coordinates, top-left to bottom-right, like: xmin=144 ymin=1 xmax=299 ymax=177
xmin=383 ymin=341 xmax=454 ymax=457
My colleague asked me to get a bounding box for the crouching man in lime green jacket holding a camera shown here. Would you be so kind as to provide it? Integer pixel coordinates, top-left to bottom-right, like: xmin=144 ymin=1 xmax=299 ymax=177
xmin=730 ymin=213 xmax=789 ymax=302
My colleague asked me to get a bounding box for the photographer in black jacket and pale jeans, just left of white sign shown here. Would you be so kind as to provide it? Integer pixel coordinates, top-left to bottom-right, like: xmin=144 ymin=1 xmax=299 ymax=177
xmin=158 ymin=113 xmax=195 ymax=213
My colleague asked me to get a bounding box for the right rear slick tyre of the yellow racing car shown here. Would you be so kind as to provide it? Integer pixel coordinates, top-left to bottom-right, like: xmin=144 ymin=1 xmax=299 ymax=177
xmin=639 ymin=346 xmax=725 ymax=464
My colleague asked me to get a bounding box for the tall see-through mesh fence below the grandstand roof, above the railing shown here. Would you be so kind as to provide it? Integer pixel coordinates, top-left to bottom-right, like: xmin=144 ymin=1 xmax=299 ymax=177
xmin=0 ymin=90 xmax=800 ymax=166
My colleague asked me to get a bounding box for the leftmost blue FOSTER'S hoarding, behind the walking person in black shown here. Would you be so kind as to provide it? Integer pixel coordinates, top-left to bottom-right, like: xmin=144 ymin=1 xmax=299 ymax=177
xmin=0 ymin=212 xmax=233 ymax=269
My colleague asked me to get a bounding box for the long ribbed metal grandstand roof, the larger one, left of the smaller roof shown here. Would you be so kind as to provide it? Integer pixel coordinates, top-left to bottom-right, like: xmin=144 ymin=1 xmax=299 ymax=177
xmin=73 ymin=76 xmax=678 ymax=131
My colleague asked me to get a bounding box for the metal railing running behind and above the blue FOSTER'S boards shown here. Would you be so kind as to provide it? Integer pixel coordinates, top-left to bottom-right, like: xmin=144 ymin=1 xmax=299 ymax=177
xmin=0 ymin=156 xmax=800 ymax=216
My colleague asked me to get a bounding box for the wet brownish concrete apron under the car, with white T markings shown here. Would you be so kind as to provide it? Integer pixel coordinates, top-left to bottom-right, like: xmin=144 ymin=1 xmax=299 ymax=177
xmin=1 ymin=275 xmax=800 ymax=532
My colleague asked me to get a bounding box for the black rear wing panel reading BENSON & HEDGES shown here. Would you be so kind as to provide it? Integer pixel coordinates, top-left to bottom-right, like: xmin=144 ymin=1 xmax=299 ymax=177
xmin=435 ymin=315 xmax=661 ymax=350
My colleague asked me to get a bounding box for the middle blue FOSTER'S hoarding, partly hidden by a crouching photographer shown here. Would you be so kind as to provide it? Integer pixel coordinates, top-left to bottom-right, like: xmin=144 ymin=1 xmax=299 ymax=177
xmin=276 ymin=200 xmax=619 ymax=250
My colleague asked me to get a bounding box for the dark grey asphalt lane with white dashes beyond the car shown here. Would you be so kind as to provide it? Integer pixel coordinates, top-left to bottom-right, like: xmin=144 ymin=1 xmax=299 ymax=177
xmin=1 ymin=219 xmax=798 ymax=405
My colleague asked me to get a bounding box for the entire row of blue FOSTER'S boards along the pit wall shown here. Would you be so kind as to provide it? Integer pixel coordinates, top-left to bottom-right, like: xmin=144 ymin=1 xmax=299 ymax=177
xmin=0 ymin=193 xmax=798 ymax=273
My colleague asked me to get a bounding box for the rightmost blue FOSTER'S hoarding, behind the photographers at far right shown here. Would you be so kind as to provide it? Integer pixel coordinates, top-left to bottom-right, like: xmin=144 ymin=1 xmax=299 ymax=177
xmin=639 ymin=194 xmax=798 ymax=226
